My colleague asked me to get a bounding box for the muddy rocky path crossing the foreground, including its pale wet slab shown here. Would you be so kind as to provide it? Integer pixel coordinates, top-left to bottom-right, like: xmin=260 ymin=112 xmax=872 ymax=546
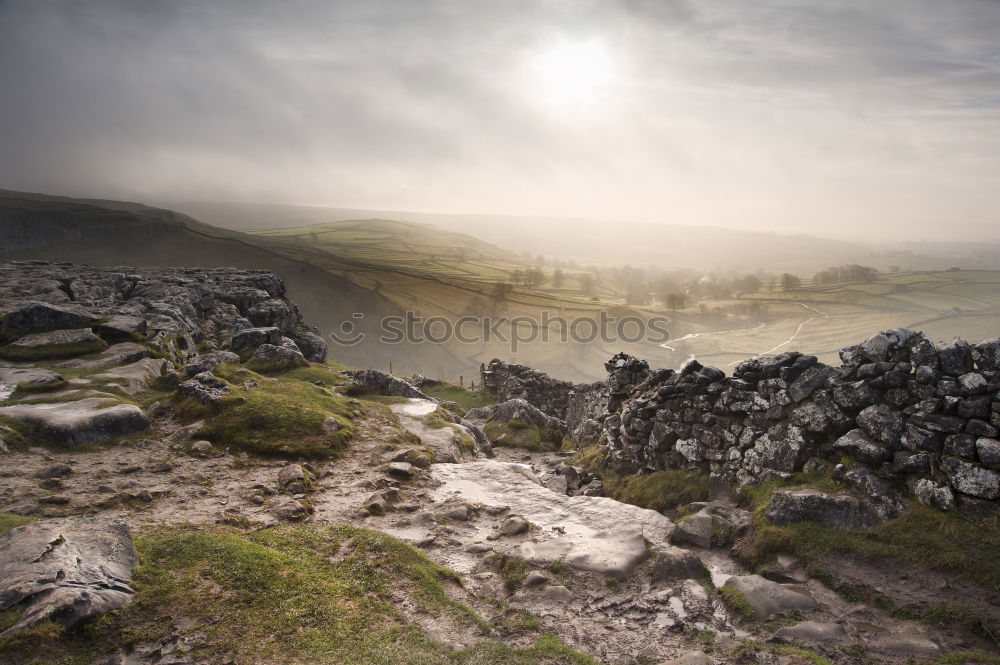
xmin=0 ymin=400 xmax=984 ymax=664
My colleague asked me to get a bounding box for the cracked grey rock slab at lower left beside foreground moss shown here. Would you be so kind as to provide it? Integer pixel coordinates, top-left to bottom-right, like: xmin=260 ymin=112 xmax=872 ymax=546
xmin=0 ymin=517 xmax=139 ymax=635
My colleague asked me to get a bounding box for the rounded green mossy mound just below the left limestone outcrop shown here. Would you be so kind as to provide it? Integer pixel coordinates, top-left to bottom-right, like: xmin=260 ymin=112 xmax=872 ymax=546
xmin=189 ymin=370 xmax=353 ymax=458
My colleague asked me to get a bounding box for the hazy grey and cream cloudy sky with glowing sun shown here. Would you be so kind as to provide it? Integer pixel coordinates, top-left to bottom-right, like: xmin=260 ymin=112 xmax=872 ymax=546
xmin=0 ymin=0 xmax=1000 ymax=239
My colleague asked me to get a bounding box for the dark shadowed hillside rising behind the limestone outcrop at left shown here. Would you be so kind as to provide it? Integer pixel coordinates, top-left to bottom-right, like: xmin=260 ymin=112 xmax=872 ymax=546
xmin=0 ymin=190 xmax=459 ymax=371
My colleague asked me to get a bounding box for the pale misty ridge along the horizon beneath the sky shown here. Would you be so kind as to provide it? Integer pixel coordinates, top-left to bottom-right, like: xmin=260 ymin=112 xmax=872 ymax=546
xmin=160 ymin=197 xmax=1000 ymax=274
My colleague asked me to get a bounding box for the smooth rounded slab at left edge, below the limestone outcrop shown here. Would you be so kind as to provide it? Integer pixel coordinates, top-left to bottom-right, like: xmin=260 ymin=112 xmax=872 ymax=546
xmin=0 ymin=397 xmax=149 ymax=445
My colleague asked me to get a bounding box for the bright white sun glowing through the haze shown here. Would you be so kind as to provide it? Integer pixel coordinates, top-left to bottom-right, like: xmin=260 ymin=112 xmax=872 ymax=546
xmin=531 ymin=39 xmax=614 ymax=111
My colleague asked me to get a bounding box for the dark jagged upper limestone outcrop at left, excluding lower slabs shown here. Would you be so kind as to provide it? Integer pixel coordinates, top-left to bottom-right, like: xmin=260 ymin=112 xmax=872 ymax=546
xmin=0 ymin=261 xmax=326 ymax=362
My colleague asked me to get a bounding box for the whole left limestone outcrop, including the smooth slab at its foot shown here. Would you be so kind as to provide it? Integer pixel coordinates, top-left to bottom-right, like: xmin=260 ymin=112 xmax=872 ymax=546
xmin=0 ymin=261 xmax=326 ymax=446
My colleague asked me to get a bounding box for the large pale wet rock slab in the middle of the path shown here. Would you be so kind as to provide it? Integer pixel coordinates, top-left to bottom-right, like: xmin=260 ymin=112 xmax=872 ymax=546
xmin=431 ymin=460 xmax=674 ymax=576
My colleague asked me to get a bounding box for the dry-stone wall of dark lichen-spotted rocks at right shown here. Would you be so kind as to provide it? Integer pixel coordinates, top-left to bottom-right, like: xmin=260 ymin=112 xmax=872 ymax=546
xmin=487 ymin=329 xmax=1000 ymax=510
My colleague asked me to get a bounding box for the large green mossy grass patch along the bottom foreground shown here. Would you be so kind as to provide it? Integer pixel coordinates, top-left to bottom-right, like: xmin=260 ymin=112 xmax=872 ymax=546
xmin=0 ymin=525 xmax=596 ymax=665
